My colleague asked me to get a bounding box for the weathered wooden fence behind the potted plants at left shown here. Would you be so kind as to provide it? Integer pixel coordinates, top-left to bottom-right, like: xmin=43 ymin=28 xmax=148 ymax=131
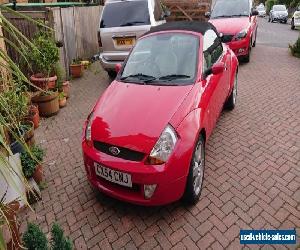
xmin=4 ymin=6 xmax=102 ymax=75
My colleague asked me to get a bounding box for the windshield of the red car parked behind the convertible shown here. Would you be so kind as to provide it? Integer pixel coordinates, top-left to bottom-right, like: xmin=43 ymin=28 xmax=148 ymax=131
xmin=211 ymin=0 xmax=250 ymax=18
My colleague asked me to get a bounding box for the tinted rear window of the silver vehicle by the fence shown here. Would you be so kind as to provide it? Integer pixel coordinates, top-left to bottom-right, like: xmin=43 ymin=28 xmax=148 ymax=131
xmin=100 ymin=1 xmax=150 ymax=28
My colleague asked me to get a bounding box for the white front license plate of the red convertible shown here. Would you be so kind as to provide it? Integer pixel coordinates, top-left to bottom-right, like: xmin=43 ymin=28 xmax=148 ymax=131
xmin=94 ymin=163 xmax=132 ymax=187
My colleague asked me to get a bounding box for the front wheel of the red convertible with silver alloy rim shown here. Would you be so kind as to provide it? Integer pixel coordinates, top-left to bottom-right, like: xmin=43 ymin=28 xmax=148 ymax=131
xmin=183 ymin=135 xmax=205 ymax=205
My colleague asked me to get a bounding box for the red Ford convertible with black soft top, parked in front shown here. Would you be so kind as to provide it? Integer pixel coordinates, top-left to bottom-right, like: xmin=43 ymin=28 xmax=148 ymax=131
xmin=82 ymin=22 xmax=238 ymax=205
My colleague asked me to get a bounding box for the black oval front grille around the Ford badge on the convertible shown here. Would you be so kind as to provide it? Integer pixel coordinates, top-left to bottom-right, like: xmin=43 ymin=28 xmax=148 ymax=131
xmin=94 ymin=141 xmax=145 ymax=161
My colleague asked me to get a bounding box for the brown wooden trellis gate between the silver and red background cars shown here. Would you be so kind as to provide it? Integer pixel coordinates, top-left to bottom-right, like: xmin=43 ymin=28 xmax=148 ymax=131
xmin=162 ymin=0 xmax=211 ymax=21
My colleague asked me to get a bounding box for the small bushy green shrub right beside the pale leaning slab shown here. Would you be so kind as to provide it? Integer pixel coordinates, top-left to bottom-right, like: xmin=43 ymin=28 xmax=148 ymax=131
xmin=21 ymin=146 xmax=45 ymax=178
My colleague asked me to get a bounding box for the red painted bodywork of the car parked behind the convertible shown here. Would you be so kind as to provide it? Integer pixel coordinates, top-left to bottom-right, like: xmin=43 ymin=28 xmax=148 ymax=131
xmin=209 ymin=16 xmax=258 ymax=56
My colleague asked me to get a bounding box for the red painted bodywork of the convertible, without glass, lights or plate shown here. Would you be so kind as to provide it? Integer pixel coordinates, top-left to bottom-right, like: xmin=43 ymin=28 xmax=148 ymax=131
xmin=82 ymin=31 xmax=238 ymax=206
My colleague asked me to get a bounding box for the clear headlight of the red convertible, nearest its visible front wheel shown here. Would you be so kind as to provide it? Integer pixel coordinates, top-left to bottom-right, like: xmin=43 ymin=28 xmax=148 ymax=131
xmin=147 ymin=125 xmax=178 ymax=165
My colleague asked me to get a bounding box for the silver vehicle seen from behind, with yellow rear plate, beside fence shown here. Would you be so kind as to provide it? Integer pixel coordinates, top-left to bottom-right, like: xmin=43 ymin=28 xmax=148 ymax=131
xmin=98 ymin=0 xmax=169 ymax=77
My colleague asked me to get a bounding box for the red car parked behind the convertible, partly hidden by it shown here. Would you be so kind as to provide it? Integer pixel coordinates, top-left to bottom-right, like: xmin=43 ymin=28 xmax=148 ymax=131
xmin=206 ymin=0 xmax=258 ymax=62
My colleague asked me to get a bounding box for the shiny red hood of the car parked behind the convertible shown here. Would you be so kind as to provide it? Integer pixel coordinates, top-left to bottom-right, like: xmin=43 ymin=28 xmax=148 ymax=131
xmin=209 ymin=17 xmax=250 ymax=35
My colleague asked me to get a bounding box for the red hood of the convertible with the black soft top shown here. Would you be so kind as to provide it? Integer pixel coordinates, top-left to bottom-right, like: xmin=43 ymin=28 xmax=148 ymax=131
xmin=92 ymin=81 xmax=193 ymax=153
